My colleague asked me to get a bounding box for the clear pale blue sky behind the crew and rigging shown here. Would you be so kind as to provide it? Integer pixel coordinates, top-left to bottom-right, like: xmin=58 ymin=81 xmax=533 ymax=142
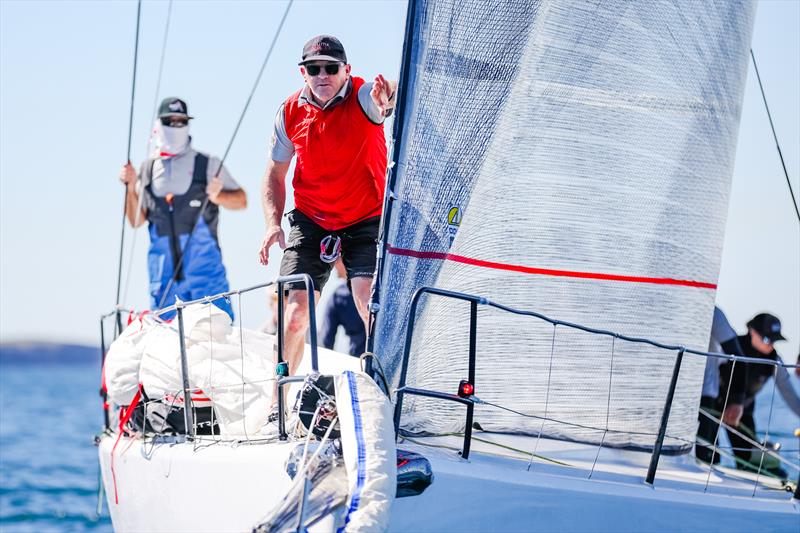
xmin=0 ymin=0 xmax=800 ymax=361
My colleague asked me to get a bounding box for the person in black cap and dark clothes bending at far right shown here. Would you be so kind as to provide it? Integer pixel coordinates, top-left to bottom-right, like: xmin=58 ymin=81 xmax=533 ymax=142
xmin=718 ymin=313 xmax=800 ymax=477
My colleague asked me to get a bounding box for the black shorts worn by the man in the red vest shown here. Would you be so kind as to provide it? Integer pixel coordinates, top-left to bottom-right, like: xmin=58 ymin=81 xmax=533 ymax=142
xmin=280 ymin=209 xmax=381 ymax=291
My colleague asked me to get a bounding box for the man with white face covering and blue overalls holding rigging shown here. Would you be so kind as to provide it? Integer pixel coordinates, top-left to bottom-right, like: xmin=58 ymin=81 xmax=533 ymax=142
xmin=119 ymin=97 xmax=247 ymax=318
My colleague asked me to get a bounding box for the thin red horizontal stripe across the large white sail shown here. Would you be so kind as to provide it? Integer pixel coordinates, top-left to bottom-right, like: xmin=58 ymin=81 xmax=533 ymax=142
xmin=386 ymin=245 xmax=717 ymax=289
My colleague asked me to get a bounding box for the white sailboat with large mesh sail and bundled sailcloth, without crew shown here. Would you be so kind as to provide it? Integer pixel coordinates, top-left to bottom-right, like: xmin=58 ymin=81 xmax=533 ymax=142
xmin=99 ymin=0 xmax=800 ymax=531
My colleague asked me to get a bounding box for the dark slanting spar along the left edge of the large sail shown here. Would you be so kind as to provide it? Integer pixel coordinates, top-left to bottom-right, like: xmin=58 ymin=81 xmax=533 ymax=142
xmin=367 ymin=0 xmax=417 ymax=358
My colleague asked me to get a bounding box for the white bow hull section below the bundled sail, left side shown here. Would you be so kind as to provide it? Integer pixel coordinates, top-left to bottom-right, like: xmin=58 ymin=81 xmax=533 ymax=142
xmin=100 ymin=437 xmax=293 ymax=533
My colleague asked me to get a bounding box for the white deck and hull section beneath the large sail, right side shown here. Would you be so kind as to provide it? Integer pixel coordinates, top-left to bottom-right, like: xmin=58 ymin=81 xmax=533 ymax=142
xmin=392 ymin=433 xmax=800 ymax=532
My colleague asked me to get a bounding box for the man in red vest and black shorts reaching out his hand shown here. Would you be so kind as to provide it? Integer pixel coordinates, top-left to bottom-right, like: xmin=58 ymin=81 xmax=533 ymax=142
xmin=259 ymin=35 xmax=397 ymax=416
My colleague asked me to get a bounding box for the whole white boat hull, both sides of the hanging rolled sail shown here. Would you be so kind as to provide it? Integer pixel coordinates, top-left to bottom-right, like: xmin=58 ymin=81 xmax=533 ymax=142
xmin=100 ymin=434 xmax=800 ymax=532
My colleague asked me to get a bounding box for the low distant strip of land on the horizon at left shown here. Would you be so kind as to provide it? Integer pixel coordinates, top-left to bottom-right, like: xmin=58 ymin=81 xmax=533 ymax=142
xmin=0 ymin=341 xmax=100 ymax=366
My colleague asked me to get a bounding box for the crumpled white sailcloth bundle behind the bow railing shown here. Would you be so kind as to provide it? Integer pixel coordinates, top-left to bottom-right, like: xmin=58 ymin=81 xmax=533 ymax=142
xmin=105 ymin=304 xmax=274 ymax=438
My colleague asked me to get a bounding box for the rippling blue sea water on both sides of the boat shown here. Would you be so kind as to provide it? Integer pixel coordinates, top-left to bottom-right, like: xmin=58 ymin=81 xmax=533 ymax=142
xmin=0 ymin=352 xmax=800 ymax=533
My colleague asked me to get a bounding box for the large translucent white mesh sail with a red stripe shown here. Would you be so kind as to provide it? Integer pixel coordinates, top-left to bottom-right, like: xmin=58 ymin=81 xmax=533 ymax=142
xmin=375 ymin=0 xmax=755 ymax=450
